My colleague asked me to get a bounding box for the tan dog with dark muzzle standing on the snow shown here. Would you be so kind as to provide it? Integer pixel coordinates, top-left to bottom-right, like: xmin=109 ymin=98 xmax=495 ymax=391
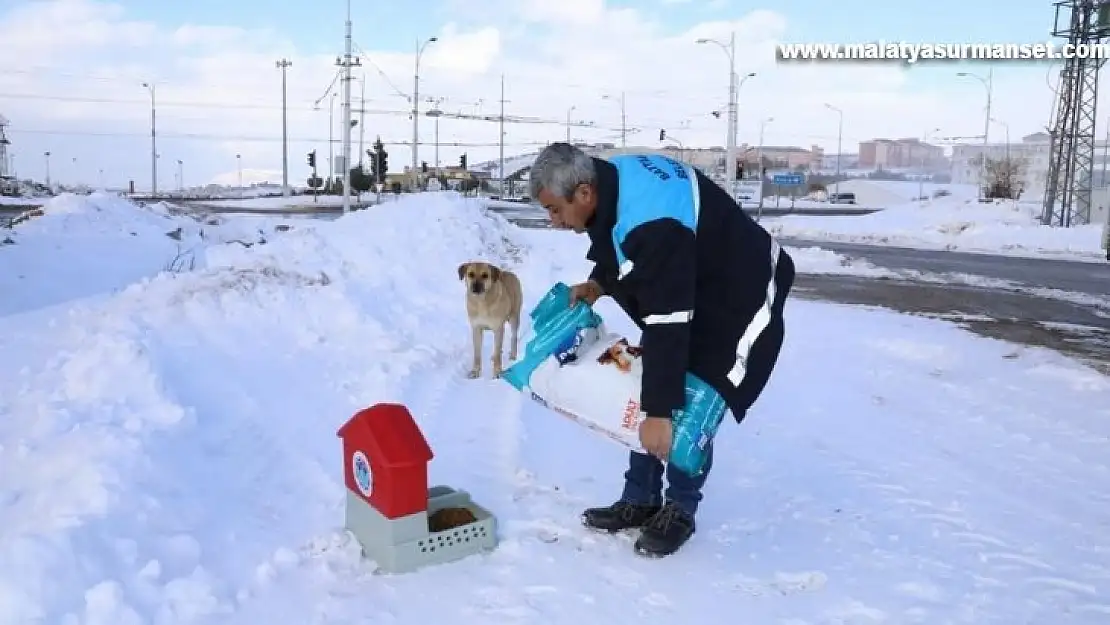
xmin=458 ymin=262 xmax=524 ymax=379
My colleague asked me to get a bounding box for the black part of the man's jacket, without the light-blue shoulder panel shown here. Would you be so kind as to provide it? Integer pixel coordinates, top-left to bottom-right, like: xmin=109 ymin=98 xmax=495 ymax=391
xmin=586 ymin=159 xmax=795 ymax=422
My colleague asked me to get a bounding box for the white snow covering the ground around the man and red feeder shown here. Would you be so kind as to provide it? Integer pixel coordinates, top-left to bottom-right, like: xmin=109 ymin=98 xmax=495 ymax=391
xmin=0 ymin=194 xmax=1110 ymax=625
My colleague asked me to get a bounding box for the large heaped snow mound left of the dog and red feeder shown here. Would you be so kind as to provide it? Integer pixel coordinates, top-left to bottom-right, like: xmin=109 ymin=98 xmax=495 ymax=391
xmin=0 ymin=190 xmax=539 ymax=625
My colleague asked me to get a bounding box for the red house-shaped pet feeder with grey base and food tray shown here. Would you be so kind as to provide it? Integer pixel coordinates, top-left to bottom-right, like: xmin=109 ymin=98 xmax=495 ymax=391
xmin=339 ymin=403 xmax=497 ymax=573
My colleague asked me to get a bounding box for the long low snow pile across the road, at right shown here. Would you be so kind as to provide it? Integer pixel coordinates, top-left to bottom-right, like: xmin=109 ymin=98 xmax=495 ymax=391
xmin=765 ymin=196 xmax=1106 ymax=259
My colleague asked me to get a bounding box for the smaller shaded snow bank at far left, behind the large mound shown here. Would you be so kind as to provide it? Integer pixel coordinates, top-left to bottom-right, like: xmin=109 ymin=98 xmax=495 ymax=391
xmin=0 ymin=193 xmax=281 ymax=316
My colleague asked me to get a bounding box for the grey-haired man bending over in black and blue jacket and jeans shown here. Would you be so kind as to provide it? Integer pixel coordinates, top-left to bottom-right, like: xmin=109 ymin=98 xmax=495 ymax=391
xmin=531 ymin=143 xmax=795 ymax=556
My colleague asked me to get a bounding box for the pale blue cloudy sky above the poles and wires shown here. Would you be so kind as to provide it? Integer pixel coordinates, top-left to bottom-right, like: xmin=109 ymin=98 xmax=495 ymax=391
xmin=0 ymin=0 xmax=1083 ymax=190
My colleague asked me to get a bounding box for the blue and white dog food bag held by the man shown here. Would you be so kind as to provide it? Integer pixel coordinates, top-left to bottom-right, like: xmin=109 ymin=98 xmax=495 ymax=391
xmin=502 ymin=282 xmax=727 ymax=475
